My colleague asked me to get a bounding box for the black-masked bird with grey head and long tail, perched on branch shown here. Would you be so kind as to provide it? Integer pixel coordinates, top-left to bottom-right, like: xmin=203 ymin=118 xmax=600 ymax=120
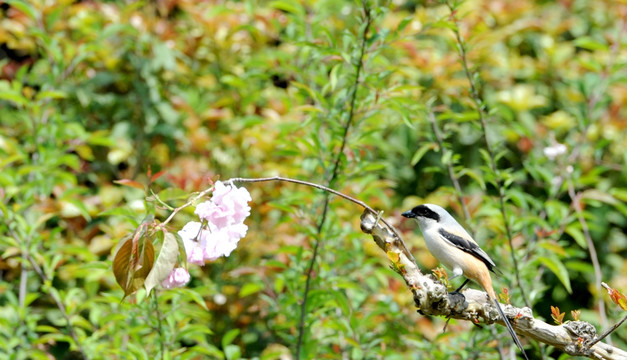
xmin=402 ymin=204 xmax=529 ymax=360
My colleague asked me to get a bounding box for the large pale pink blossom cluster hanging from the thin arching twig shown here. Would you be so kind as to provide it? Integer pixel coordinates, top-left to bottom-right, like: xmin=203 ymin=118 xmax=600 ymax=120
xmin=178 ymin=181 xmax=252 ymax=265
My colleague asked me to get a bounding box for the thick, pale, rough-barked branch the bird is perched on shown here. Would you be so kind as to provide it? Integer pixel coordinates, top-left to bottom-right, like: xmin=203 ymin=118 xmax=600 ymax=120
xmin=361 ymin=211 xmax=627 ymax=360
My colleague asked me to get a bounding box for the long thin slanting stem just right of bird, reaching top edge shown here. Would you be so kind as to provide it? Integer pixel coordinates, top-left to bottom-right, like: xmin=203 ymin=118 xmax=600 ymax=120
xmin=447 ymin=3 xmax=531 ymax=307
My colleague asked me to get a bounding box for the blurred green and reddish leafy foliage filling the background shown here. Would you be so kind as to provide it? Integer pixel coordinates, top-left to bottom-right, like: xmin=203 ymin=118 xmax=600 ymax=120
xmin=0 ymin=0 xmax=627 ymax=359
